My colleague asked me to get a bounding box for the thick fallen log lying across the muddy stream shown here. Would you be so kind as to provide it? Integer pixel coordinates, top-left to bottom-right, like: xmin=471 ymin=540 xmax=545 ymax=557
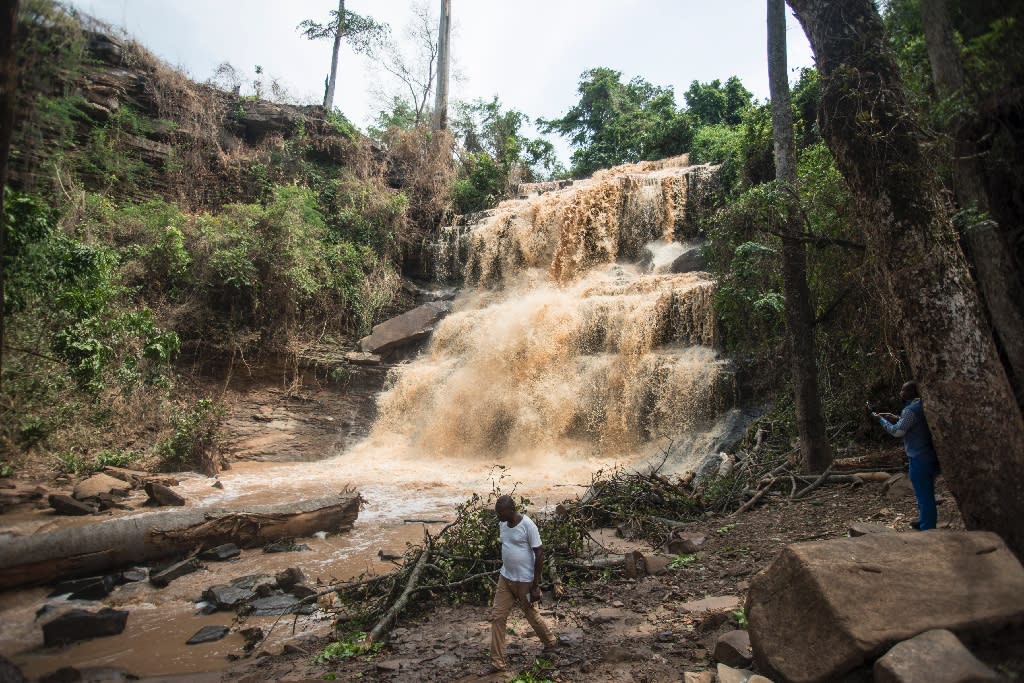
xmin=0 ymin=492 xmax=361 ymax=590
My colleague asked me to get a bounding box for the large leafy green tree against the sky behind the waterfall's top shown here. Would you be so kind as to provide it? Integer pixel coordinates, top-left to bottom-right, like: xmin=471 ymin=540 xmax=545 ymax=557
xmin=539 ymin=68 xmax=692 ymax=177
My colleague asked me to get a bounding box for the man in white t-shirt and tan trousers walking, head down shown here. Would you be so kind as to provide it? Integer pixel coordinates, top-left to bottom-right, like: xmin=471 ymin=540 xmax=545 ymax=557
xmin=490 ymin=496 xmax=558 ymax=672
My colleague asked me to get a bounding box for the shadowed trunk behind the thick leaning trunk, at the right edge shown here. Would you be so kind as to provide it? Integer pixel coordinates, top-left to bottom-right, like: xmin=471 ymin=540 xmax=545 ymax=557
xmin=921 ymin=0 xmax=1024 ymax=405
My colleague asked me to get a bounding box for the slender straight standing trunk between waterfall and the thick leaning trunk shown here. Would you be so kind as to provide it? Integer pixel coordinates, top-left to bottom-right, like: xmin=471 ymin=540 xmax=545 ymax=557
xmin=768 ymin=0 xmax=831 ymax=472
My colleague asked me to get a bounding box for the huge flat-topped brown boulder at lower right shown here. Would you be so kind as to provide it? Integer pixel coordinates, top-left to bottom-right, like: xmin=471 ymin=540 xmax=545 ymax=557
xmin=746 ymin=530 xmax=1024 ymax=683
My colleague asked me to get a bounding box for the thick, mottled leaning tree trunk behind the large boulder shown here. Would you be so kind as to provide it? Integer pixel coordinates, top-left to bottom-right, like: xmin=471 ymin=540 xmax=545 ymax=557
xmin=788 ymin=0 xmax=1024 ymax=557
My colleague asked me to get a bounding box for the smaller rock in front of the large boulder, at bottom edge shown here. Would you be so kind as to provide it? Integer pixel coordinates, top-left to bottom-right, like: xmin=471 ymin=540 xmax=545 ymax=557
xmin=874 ymin=629 xmax=1002 ymax=683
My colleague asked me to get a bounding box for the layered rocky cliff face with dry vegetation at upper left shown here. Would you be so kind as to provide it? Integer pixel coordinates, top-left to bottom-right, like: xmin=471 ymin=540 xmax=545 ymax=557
xmin=10 ymin=17 xmax=372 ymax=209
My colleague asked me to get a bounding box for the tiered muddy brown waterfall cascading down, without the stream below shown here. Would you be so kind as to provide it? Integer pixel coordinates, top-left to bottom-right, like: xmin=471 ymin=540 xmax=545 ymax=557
xmin=374 ymin=157 xmax=734 ymax=459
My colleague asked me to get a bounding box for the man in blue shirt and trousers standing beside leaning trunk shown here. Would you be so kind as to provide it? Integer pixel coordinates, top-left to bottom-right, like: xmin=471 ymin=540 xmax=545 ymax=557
xmin=871 ymin=382 xmax=939 ymax=531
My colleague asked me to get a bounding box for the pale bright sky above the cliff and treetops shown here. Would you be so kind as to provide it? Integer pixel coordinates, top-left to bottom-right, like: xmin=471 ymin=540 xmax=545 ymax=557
xmin=64 ymin=0 xmax=813 ymax=156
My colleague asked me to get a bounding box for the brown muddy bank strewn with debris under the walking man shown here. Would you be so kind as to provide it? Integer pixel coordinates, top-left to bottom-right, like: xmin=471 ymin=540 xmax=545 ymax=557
xmin=220 ymin=479 xmax=962 ymax=683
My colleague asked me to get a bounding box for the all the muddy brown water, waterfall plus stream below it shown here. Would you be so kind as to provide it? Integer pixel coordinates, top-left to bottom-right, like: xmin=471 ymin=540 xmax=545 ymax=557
xmin=0 ymin=157 xmax=737 ymax=675
